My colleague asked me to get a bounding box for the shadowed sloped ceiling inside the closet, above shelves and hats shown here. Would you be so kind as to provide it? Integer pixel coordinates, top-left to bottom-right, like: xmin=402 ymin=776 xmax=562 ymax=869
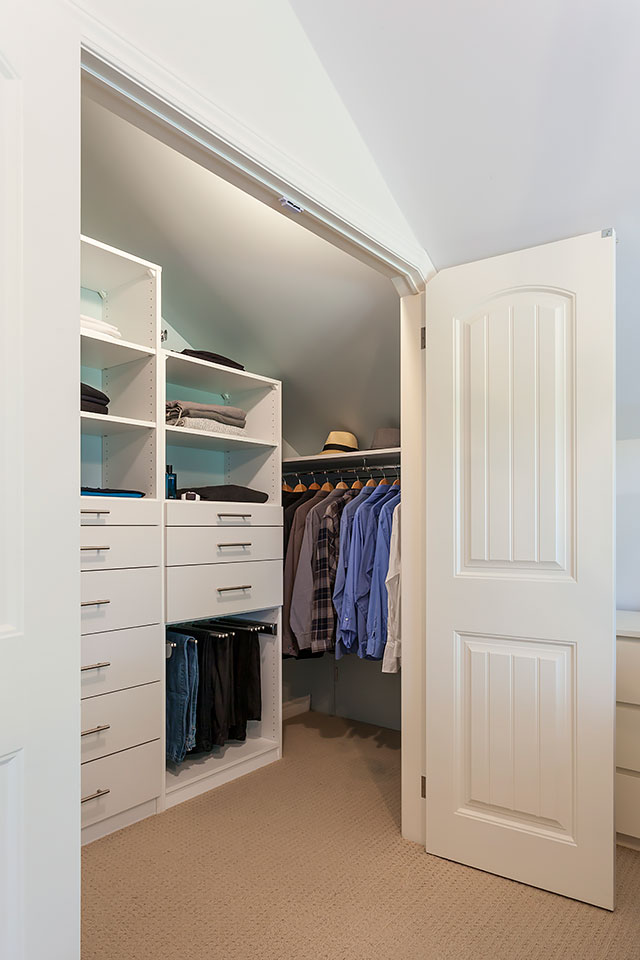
xmin=82 ymin=97 xmax=400 ymax=454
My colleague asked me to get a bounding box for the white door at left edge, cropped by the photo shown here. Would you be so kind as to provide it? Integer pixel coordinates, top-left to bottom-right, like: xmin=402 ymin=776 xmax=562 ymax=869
xmin=0 ymin=0 xmax=80 ymax=960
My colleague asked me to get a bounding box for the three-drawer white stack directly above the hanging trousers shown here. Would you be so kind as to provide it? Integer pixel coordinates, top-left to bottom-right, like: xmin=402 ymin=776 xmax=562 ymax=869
xmin=166 ymin=500 xmax=282 ymax=623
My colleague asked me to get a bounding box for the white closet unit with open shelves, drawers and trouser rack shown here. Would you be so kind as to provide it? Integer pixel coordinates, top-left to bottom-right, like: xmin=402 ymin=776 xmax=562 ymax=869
xmin=80 ymin=237 xmax=282 ymax=841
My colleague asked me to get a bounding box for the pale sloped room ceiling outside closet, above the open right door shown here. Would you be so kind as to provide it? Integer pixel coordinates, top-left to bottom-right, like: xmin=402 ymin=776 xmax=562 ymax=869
xmin=291 ymin=0 xmax=640 ymax=437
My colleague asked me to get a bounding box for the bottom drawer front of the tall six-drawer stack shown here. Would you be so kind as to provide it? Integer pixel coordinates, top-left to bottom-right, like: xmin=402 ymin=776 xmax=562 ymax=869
xmin=81 ymin=740 xmax=164 ymax=827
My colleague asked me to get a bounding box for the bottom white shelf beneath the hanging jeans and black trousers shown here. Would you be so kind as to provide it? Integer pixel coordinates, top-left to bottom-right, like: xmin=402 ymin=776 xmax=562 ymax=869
xmin=166 ymin=737 xmax=279 ymax=806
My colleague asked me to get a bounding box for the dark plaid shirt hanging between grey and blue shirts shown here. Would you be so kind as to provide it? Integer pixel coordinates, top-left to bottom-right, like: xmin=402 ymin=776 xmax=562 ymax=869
xmin=311 ymin=490 xmax=359 ymax=653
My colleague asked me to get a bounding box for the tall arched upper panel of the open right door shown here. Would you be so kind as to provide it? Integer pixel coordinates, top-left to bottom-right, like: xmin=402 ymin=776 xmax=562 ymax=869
xmin=455 ymin=288 xmax=575 ymax=579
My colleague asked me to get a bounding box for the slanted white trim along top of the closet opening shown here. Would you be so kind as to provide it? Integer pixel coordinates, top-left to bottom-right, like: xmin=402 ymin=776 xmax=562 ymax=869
xmin=81 ymin=34 xmax=435 ymax=296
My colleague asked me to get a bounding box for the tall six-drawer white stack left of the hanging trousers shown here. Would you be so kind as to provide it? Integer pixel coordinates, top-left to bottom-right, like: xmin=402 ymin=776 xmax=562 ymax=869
xmin=80 ymin=497 xmax=164 ymax=839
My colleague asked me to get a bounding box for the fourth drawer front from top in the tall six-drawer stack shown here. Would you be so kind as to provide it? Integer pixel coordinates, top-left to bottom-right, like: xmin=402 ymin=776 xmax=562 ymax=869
xmin=80 ymin=626 xmax=164 ymax=699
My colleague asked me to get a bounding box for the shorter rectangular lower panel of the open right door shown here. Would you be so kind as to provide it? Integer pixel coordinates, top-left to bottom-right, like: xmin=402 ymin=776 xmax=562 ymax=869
xmin=455 ymin=634 xmax=576 ymax=842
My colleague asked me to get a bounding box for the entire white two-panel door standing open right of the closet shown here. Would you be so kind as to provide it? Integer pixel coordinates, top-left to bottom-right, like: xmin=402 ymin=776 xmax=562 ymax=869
xmin=426 ymin=231 xmax=615 ymax=909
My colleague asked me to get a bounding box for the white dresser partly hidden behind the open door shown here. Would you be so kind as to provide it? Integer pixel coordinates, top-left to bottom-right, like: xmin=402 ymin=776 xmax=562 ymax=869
xmin=616 ymin=610 xmax=640 ymax=837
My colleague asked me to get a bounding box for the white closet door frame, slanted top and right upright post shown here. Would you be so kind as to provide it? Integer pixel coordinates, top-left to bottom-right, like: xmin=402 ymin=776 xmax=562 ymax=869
xmin=82 ymin=33 xmax=434 ymax=843
